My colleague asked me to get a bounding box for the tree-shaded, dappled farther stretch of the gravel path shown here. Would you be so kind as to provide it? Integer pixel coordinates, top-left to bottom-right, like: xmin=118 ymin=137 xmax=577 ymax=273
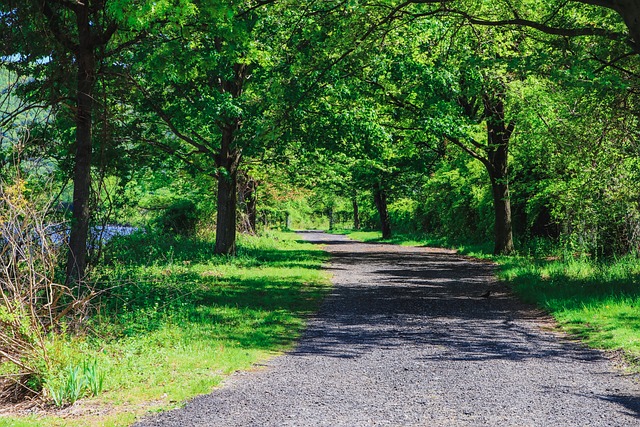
xmin=296 ymin=231 xmax=598 ymax=361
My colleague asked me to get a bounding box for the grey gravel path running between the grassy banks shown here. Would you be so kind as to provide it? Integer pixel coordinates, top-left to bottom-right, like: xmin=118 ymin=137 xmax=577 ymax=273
xmin=137 ymin=232 xmax=640 ymax=427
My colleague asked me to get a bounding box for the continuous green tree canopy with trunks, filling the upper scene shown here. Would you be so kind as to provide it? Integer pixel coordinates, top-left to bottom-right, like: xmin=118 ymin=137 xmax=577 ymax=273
xmin=0 ymin=0 xmax=640 ymax=262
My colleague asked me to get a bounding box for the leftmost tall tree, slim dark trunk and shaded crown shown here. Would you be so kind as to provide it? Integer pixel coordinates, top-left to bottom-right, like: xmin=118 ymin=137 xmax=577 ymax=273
xmin=0 ymin=0 xmax=127 ymax=283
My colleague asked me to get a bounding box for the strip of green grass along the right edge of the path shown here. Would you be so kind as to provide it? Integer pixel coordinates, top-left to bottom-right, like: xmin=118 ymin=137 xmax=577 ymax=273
xmin=338 ymin=231 xmax=640 ymax=371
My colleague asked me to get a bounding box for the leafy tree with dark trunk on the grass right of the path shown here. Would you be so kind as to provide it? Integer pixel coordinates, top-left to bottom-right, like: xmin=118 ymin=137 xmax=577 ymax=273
xmin=340 ymin=10 xmax=519 ymax=254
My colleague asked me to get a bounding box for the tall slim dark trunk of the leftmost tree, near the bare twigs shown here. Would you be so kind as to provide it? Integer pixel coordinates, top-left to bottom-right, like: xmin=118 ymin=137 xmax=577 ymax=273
xmin=67 ymin=6 xmax=96 ymax=284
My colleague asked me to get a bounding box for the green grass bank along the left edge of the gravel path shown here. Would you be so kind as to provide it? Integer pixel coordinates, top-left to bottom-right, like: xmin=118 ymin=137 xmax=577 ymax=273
xmin=0 ymin=233 xmax=329 ymax=426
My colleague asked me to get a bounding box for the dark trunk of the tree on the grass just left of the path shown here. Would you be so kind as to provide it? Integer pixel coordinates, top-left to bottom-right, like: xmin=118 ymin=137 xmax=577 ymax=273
xmin=215 ymin=122 xmax=240 ymax=255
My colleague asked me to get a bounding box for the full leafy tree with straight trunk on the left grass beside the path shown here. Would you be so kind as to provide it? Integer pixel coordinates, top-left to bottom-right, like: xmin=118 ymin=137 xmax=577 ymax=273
xmin=128 ymin=0 xmax=302 ymax=255
